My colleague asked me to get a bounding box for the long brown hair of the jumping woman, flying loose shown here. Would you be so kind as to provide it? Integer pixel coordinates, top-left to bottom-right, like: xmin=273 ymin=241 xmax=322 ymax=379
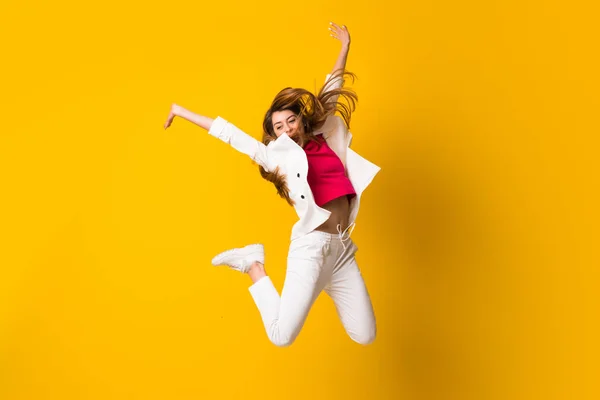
xmin=259 ymin=69 xmax=358 ymax=206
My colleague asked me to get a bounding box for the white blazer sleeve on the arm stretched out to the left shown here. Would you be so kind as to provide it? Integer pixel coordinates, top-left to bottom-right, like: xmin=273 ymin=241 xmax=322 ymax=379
xmin=208 ymin=117 xmax=271 ymax=171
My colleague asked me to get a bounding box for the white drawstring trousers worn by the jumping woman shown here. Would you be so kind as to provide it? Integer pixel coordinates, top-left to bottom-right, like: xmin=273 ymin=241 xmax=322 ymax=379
xmin=249 ymin=231 xmax=376 ymax=346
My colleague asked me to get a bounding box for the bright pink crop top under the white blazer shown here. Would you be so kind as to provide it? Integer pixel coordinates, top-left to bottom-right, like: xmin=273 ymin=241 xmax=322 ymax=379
xmin=304 ymin=135 xmax=356 ymax=207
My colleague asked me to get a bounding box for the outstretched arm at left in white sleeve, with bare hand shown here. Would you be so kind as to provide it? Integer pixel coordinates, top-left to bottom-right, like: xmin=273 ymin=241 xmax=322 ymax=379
xmin=164 ymin=104 xmax=272 ymax=171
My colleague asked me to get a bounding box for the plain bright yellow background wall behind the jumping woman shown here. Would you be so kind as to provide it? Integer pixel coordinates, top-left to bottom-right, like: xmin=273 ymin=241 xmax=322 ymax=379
xmin=0 ymin=0 xmax=600 ymax=400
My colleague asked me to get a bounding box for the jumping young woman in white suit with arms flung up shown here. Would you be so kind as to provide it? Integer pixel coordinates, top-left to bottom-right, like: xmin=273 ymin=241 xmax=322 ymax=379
xmin=164 ymin=23 xmax=380 ymax=346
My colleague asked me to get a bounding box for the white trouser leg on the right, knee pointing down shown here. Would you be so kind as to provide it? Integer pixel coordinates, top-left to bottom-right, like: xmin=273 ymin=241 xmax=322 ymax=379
xmin=325 ymin=240 xmax=377 ymax=345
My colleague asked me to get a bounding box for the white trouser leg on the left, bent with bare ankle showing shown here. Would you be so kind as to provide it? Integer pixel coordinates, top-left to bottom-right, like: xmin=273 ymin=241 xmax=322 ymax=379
xmin=249 ymin=234 xmax=330 ymax=346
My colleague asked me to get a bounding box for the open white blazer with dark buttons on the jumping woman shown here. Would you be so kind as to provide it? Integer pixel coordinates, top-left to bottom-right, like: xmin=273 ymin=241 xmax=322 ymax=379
xmin=208 ymin=78 xmax=381 ymax=240
